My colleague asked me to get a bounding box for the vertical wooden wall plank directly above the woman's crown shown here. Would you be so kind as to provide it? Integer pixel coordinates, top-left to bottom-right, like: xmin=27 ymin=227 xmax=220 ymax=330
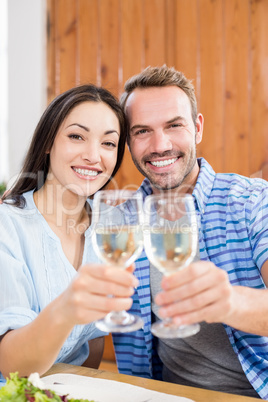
xmin=77 ymin=0 xmax=100 ymax=84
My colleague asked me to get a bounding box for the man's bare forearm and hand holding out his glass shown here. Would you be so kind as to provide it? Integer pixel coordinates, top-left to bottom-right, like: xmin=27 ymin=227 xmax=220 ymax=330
xmin=155 ymin=261 xmax=268 ymax=336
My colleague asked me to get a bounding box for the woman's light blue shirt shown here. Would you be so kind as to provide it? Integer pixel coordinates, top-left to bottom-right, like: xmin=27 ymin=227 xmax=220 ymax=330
xmin=0 ymin=191 xmax=106 ymax=387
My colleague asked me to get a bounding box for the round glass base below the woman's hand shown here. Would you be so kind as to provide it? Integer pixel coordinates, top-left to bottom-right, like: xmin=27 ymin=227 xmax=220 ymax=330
xmin=95 ymin=311 xmax=144 ymax=333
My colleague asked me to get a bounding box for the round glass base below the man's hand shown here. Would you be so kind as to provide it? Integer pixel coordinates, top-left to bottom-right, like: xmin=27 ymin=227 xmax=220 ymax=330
xmin=151 ymin=321 xmax=200 ymax=338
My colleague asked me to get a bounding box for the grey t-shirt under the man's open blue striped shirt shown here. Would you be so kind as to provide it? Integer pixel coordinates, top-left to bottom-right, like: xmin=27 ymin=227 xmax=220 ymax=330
xmin=150 ymin=264 xmax=259 ymax=398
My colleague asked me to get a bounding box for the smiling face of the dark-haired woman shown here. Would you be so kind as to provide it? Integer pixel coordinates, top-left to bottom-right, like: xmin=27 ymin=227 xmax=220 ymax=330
xmin=46 ymin=102 xmax=120 ymax=197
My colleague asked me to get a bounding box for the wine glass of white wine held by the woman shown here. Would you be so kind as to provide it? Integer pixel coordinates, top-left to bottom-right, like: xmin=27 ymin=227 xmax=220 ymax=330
xmin=92 ymin=190 xmax=143 ymax=332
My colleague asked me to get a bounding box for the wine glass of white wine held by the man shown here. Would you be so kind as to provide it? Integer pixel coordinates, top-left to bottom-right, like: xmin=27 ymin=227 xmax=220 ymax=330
xmin=144 ymin=193 xmax=200 ymax=338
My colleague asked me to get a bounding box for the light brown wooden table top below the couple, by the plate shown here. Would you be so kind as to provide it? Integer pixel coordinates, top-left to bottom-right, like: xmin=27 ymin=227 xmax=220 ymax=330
xmin=44 ymin=363 xmax=260 ymax=402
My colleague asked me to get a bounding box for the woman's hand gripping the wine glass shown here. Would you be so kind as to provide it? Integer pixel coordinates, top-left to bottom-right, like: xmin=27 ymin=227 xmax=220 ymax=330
xmin=57 ymin=264 xmax=138 ymax=326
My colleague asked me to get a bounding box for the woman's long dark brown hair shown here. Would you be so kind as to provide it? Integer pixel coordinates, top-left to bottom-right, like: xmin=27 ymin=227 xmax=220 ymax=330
xmin=2 ymin=84 xmax=127 ymax=208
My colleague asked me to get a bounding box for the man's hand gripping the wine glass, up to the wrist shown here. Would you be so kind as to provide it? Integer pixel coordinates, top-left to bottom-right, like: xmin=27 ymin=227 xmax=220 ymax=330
xmin=155 ymin=261 xmax=234 ymax=324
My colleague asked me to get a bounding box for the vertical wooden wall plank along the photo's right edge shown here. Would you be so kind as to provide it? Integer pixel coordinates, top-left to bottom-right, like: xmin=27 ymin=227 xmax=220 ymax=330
xmin=249 ymin=0 xmax=268 ymax=180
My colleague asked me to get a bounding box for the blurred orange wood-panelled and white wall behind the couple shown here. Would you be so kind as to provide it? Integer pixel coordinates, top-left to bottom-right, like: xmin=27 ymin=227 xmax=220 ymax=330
xmin=0 ymin=0 xmax=268 ymax=359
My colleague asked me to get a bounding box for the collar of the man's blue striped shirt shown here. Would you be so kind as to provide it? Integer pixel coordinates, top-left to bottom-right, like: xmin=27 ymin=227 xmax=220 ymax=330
xmin=138 ymin=158 xmax=216 ymax=214
